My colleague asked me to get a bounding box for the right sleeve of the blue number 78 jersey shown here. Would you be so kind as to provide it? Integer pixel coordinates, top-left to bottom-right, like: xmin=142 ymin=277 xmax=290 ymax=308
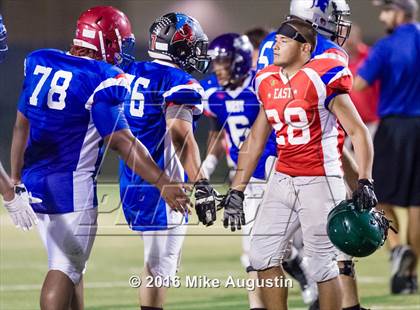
xmin=90 ymin=71 xmax=130 ymax=137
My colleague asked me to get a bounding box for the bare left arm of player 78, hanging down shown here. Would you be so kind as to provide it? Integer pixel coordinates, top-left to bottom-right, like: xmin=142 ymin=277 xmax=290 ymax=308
xmin=10 ymin=112 xmax=29 ymax=184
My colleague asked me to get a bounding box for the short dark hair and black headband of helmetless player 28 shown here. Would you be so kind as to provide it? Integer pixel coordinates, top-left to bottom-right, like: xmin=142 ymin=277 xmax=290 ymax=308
xmin=277 ymin=19 xmax=317 ymax=52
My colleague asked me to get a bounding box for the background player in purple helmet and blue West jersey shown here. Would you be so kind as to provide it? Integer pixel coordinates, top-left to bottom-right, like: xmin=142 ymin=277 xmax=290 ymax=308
xmin=201 ymin=33 xmax=317 ymax=309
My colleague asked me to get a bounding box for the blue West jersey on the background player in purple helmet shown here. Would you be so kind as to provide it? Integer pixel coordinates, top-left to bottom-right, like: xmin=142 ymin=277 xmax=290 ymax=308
xmin=201 ymin=71 xmax=277 ymax=179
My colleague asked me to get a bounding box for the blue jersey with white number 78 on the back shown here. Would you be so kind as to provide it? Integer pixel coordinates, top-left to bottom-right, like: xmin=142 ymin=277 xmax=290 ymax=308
xmin=18 ymin=49 xmax=129 ymax=213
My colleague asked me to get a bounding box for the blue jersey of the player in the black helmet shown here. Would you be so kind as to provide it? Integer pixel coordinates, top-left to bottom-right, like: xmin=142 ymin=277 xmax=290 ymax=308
xmin=120 ymin=60 xmax=203 ymax=231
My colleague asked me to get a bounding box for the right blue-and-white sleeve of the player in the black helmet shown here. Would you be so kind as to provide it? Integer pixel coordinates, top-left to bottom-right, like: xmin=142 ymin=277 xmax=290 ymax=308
xmin=162 ymin=73 xmax=204 ymax=115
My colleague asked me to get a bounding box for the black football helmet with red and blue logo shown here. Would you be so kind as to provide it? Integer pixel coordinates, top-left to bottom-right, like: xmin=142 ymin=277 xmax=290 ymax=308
xmin=149 ymin=13 xmax=210 ymax=73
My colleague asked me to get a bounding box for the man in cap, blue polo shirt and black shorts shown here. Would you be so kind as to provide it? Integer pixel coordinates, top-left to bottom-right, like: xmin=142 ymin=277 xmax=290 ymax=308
xmin=354 ymin=0 xmax=420 ymax=294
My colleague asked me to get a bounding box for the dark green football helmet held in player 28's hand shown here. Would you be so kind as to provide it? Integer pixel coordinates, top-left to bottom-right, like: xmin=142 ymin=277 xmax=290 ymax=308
xmin=327 ymin=200 xmax=393 ymax=257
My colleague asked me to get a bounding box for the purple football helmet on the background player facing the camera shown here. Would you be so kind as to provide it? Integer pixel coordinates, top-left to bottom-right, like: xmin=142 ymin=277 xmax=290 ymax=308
xmin=209 ymin=33 xmax=253 ymax=84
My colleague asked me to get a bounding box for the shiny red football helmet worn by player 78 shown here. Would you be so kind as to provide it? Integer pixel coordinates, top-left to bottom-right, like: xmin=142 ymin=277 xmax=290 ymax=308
xmin=73 ymin=6 xmax=135 ymax=65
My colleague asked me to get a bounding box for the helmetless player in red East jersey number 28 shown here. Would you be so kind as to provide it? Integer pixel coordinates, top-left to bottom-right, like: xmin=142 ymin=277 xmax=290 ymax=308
xmin=222 ymin=19 xmax=376 ymax=310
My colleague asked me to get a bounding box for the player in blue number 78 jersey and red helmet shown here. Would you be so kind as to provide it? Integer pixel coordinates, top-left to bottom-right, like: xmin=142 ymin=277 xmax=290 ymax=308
xmin=11 ymin=6 xmax=188 ymax=310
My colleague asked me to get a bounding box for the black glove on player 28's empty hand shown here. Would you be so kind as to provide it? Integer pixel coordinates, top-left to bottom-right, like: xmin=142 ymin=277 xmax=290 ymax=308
xmin=220 ymin=189 xmax=245 ymax=231
